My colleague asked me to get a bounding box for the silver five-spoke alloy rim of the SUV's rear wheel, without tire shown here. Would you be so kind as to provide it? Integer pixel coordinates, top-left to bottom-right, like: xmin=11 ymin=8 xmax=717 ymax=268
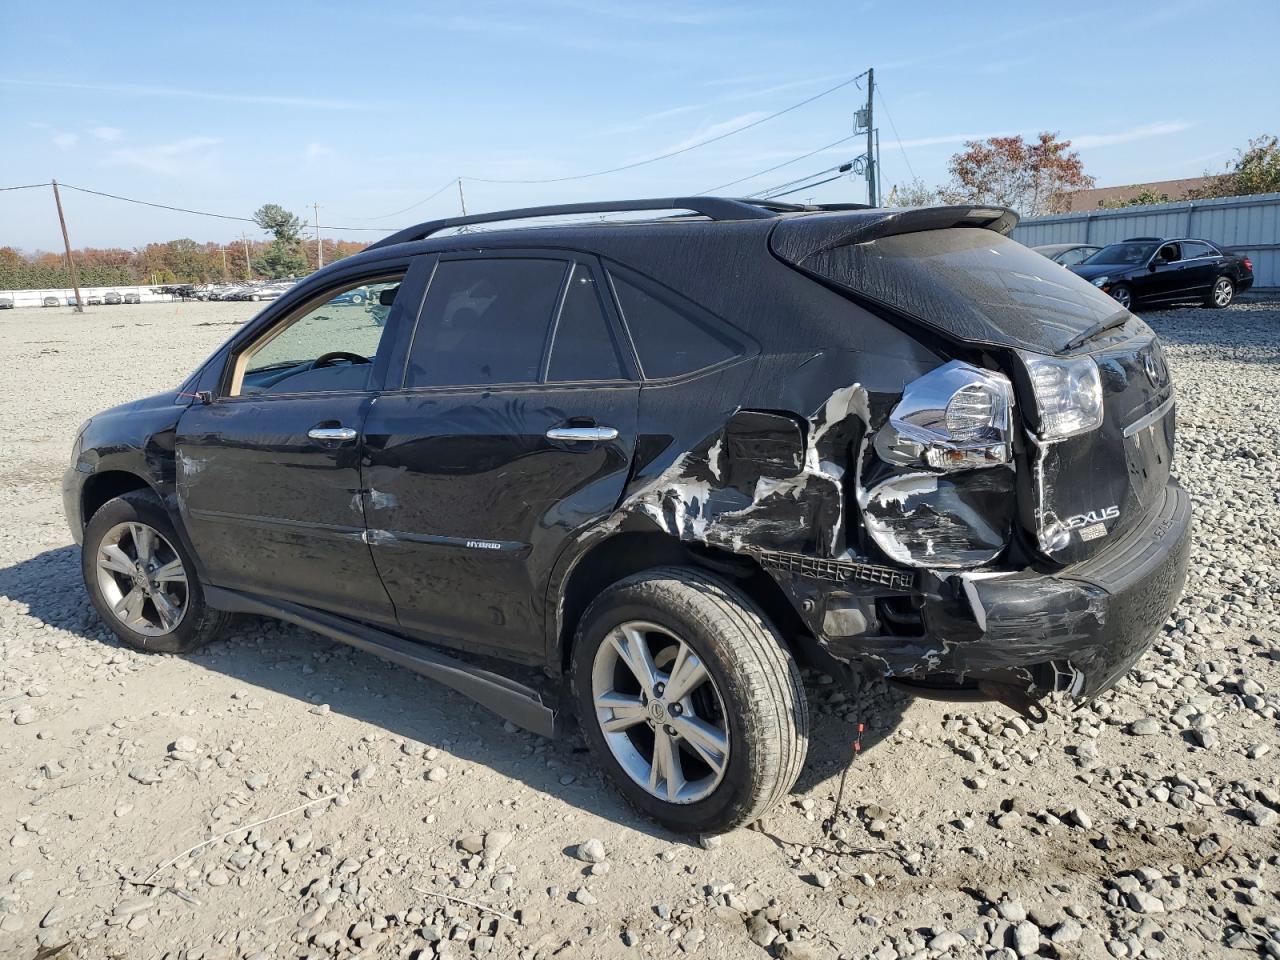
xmin=591 ymin=621 xmax=730 ymax=804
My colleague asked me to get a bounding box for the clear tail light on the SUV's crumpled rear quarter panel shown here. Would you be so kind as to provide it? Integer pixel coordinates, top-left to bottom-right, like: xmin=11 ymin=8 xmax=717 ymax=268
xmin=876 ymin=360 xmax=1014 ymax=471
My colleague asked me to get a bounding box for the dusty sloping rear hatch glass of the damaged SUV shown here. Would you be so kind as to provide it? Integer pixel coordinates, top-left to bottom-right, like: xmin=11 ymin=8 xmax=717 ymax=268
xmin=774 ymin=227 xmax=1121 ymax=353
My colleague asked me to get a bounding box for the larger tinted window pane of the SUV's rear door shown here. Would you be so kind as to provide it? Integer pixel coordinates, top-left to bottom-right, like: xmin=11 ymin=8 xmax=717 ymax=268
xmin=404 ymin=259 xmax=568 ymax=387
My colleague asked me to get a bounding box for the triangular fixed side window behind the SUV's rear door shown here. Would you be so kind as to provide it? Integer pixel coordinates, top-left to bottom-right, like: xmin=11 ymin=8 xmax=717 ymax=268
xmin=611 ymin=273 xmax=740 ymax=380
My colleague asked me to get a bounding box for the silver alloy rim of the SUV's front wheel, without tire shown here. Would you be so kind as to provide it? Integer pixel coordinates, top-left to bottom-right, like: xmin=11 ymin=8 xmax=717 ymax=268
xmin=95 ymin=521 xmax=188 ymax=636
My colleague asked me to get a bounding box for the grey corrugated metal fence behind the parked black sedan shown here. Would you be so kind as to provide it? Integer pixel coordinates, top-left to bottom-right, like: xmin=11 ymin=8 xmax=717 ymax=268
xmin=1012 ymin=193 xmax=1280 ymax=288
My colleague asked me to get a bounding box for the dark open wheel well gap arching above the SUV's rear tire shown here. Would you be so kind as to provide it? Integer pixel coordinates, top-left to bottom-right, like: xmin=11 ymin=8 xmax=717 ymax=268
xmin=558 ymin=532 xmax=808 ymax=669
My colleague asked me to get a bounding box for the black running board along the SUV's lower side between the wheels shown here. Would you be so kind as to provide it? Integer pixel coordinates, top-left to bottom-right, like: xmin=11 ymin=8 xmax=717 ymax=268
xmin=205 ymin=586 xmax=556 ymax=737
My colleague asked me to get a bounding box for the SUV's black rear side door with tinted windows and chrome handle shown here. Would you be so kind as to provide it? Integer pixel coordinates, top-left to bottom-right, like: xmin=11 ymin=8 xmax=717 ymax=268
xmin=365 ymin=251 xmax=639 ymax=660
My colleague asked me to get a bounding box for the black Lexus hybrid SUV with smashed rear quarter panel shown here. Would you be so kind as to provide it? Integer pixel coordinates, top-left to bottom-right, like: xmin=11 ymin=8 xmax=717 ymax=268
xmin=64 ymin=197 xmax=1190 ymax=832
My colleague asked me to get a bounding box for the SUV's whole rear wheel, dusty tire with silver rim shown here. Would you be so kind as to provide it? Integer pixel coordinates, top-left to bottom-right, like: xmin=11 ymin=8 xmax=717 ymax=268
xmin=572 ymin=567 xmax=809 ymax=833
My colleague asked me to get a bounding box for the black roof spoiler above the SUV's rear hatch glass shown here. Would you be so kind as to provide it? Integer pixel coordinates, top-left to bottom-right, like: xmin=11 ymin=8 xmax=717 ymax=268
xmin=769 ymin=205 xmax=1018 ymax=266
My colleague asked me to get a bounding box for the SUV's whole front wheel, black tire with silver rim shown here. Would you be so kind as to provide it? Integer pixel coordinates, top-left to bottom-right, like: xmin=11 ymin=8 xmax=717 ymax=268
xmin=81 ymin=490 xmax=229 ymax=653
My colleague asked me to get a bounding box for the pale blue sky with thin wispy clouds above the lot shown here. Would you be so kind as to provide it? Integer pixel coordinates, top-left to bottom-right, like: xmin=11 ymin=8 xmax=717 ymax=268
xmin=0 ymin=0 xmax=1280 ymax=250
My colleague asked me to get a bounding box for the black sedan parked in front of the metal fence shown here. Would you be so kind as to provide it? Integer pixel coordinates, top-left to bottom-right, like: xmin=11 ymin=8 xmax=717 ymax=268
xmin=1070 ymin=237 xmax=1253 ymax=308
